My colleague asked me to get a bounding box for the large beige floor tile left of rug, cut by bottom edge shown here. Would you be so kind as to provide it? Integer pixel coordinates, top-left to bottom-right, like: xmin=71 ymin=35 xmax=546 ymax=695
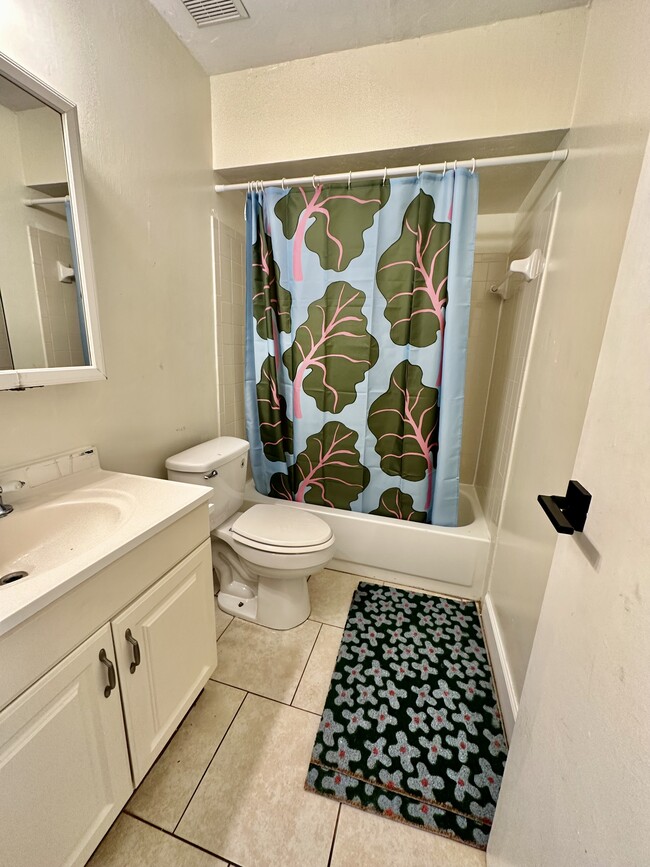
xmin=176 ymin=695 xmax=338 ymax=867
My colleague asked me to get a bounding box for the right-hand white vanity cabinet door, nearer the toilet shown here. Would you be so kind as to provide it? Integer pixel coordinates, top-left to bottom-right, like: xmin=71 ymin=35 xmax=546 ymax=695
xmin=111 ymin=541 xmax=217 ymax=786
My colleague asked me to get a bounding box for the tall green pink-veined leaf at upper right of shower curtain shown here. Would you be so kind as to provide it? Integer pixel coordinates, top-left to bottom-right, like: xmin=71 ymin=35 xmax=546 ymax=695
xmin=377 ymin=192 xmax=451 ymax=346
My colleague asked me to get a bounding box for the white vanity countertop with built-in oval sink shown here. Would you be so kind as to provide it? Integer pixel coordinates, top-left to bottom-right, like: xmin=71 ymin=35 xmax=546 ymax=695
xmin=0 ymin=467 xmax=212 ymax=635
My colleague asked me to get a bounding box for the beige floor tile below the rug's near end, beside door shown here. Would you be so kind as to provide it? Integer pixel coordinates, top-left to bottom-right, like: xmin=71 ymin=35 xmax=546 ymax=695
xmin=331 ymin=805 xmax=486 ymax=867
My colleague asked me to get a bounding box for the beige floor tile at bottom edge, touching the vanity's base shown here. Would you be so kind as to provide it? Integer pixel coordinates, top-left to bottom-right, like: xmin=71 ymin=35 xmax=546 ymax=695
xmin=88 ymin=813 xmax=227 ymax=867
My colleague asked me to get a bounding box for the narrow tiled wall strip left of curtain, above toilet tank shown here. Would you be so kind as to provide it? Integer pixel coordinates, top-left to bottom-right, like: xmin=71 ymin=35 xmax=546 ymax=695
xmin=214 ymin=220 xmax=246 ymax=437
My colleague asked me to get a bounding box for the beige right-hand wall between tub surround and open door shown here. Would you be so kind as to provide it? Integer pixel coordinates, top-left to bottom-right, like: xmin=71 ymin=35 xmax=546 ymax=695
xmin=480 ymin=0 xmax=650 ymax=696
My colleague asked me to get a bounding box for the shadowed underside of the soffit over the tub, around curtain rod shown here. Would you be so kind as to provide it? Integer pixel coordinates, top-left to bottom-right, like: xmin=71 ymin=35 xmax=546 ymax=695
xmin=215 ymin=129 xmax=567 ymax=214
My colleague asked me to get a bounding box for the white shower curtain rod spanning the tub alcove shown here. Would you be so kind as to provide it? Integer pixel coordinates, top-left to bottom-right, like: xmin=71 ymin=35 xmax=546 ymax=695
xmin=214 ymin=149 xmax=569 ymax=193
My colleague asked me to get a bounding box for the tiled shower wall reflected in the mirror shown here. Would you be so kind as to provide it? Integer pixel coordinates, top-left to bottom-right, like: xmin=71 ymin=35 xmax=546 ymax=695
xmin=29 ymin=226 xmax=84 ymax=367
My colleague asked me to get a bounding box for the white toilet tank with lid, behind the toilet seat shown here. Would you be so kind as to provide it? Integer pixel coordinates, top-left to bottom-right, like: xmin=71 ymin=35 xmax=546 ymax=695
xmin=165 ymin=437 xmax=249 ymax=530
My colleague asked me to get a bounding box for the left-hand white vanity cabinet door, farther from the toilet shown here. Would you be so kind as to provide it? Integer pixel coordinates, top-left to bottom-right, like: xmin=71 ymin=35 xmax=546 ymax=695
xmin=0 ymin=625 xmax=133 ymax=867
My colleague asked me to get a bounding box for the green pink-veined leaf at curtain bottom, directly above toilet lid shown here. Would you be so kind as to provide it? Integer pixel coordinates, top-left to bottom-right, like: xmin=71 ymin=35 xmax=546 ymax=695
xmin=269 ymin=421 xmax=370 ymax=510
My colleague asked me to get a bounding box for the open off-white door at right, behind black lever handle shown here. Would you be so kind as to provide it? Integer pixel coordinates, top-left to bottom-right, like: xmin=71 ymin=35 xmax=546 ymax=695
xmin=487 ymin=107 xmax=650 ymax=867
